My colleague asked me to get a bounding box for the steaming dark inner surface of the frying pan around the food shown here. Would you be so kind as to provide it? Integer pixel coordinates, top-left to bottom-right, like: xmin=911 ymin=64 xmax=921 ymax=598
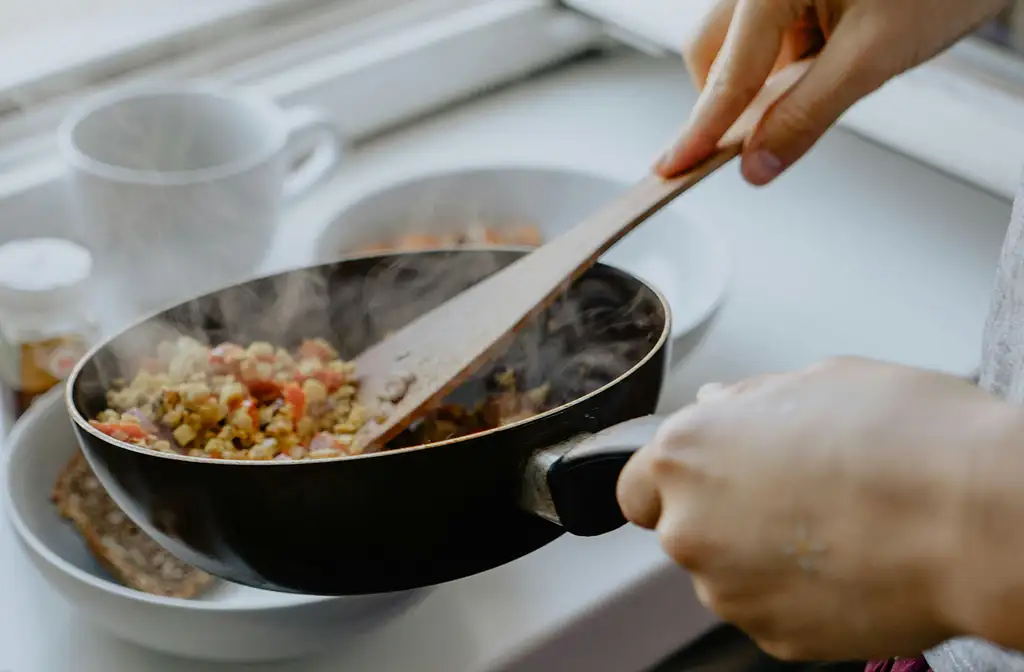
xmin=82 ymin=249 xmax=664 ymax=446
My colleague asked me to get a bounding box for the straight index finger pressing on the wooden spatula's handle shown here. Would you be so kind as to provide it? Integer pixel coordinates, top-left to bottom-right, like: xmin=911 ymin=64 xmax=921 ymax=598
xmin=655 ymin=0 xmax=806 ymax=177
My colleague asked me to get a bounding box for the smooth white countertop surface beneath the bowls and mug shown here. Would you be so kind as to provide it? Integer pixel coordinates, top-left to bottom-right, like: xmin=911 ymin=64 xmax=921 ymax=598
xmin=0 ymin=51 xmax=1010 ymax=672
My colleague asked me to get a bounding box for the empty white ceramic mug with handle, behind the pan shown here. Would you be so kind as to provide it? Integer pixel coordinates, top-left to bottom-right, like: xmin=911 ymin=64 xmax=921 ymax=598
xmin=57 ymin=83 xmax=342 ymax=317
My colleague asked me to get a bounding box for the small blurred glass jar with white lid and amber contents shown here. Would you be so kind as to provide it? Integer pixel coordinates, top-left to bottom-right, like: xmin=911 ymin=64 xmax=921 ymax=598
xmin=0 ymin=238 xmax=98 ymax=415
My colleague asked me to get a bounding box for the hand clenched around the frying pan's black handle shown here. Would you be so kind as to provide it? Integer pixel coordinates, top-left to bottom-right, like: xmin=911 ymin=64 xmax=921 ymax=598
xmin=618 ymin=359 xmax=1020 ymax=660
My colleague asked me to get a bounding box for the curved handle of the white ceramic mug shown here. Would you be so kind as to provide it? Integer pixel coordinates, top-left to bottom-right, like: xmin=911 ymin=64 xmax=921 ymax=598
xmin=284 ymin=108 xmax=344 ymax=200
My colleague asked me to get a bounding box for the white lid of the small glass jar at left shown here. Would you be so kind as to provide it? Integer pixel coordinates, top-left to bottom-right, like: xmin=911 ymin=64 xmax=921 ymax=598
xmin=0 ymin=238 xmax=92 ymax=310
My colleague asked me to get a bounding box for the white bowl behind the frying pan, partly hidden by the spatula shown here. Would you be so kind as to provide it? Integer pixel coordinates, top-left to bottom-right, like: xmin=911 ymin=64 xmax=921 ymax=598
xmin=314 ymin=166 xmax=731 ymax=361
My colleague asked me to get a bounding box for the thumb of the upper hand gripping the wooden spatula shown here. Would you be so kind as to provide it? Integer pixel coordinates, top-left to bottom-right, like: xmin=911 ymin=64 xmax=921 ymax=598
xmin=742 ymin=13 xmax=900 ymax=186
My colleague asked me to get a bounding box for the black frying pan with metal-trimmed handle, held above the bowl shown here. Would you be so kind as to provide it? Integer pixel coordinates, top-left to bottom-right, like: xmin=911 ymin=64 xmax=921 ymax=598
xmin=67 ymin=250 xmax=671 ymax=595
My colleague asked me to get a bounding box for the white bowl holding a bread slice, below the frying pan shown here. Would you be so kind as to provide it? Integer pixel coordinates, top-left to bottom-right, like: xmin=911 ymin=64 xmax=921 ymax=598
xmin=2 ymin=389 xmax=426 ymax=663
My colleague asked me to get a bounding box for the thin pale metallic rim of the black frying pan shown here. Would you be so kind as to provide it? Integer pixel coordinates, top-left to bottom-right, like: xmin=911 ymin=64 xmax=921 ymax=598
xmin=63 ymin=245 xmax=672 ymax=468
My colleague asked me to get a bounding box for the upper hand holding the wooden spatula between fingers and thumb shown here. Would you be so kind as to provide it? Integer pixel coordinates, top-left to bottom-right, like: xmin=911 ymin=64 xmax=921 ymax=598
xmin=655 ymin=0 xmax=1006 ymax=185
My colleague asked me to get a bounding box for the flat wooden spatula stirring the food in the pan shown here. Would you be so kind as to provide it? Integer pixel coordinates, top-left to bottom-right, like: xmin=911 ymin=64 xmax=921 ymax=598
xmin=352 ymin=61 xmax=810 ymax=453
